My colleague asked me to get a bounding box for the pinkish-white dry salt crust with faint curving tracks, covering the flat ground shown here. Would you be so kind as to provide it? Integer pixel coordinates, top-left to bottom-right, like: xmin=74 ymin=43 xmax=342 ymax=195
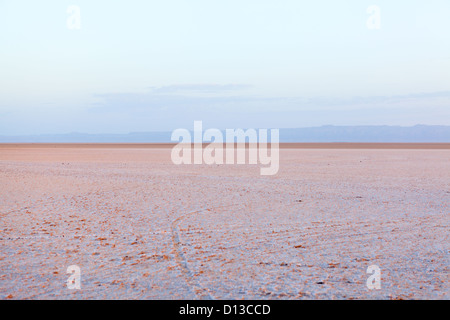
xmin=0 ymin=147 xmax=450 ymax=299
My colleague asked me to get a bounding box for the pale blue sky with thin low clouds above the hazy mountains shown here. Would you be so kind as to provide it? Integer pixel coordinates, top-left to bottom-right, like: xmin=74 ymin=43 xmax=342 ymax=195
xmin=0 ymin=0 xmax=450 ymax=135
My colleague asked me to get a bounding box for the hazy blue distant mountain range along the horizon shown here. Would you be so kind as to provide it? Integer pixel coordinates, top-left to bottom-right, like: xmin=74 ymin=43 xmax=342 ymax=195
xmin=0 ymin=125 xmax=450 ymax=143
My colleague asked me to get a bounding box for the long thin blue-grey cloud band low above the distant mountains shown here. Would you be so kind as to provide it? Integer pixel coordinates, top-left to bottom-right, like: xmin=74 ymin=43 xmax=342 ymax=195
xmin=91 ymin=88 xmax=450 ymax=117
